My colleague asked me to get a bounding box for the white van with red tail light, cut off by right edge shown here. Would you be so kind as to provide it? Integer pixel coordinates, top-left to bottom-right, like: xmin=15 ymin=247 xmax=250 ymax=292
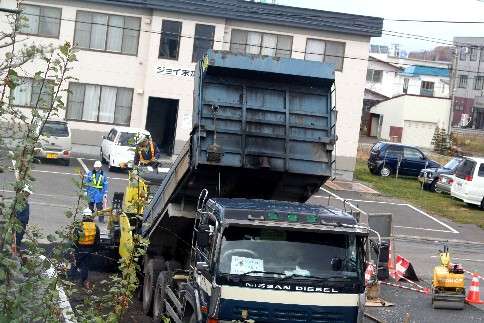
xmin=450 ymin=157 xmax=484 ymax=210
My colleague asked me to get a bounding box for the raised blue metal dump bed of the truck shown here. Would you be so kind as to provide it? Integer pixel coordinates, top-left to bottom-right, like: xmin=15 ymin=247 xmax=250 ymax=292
xmin=144 ymin=51 xmax=336 ymax=235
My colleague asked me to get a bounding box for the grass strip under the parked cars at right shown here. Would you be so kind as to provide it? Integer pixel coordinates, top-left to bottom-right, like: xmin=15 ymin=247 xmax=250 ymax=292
xmin=353 ymin=159 xmax=484 ymax=229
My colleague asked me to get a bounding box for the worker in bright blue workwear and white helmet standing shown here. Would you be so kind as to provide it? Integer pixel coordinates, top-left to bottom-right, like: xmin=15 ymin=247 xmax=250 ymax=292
xmin=84 ymin=160 xmax=108 ymax=223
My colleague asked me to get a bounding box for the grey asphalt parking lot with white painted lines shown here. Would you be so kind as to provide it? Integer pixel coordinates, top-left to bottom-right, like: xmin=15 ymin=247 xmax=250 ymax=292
xmin=0 ymin=154 xmax=484 ymax=323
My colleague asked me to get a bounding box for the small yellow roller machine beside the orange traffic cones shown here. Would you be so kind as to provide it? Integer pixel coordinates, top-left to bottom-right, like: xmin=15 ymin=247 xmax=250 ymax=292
xmin=432 ymin=245 xmax=466 ymax=310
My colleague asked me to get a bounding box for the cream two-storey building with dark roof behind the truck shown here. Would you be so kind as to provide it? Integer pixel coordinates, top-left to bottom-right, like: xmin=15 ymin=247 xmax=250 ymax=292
xmin=0 ymin=0 xmax=383 ymax=179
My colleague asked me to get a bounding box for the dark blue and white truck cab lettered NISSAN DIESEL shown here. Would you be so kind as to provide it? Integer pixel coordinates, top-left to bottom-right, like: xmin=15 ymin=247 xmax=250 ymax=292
xmin=170 ymin=198 xmax=367 ymax=322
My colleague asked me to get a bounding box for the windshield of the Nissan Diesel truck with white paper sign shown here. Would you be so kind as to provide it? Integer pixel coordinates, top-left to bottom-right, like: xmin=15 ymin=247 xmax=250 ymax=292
xmin=219 ymin=227 xmax=364 ymax=279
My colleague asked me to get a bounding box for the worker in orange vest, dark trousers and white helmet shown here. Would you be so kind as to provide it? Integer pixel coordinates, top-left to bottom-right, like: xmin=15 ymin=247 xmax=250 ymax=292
xmin=67 ymin=209 xmax=100 ymax=287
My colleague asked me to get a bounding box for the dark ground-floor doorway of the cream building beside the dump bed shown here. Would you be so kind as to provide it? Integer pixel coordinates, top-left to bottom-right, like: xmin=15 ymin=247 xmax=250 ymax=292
xmin=145 ymin=97 xmax=178 ymax=156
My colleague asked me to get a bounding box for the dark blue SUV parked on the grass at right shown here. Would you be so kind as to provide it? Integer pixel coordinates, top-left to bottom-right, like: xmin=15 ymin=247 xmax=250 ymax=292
xmin=368 ymin=142 xmax=441 ymax=176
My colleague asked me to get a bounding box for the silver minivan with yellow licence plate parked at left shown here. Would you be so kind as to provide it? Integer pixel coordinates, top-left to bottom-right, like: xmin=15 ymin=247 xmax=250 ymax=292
xmin=35 ymin=119 xmax=72 ymax=166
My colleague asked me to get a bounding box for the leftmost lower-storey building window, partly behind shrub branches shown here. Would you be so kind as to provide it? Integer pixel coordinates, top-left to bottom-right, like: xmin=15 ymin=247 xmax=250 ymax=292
xmin=10 ymin=78 xmax=54 ymax=108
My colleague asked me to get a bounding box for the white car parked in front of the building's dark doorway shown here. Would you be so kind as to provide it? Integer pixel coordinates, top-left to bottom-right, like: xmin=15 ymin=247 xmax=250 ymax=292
xmin=100 ymin=127 xmax=151 ymax=171
